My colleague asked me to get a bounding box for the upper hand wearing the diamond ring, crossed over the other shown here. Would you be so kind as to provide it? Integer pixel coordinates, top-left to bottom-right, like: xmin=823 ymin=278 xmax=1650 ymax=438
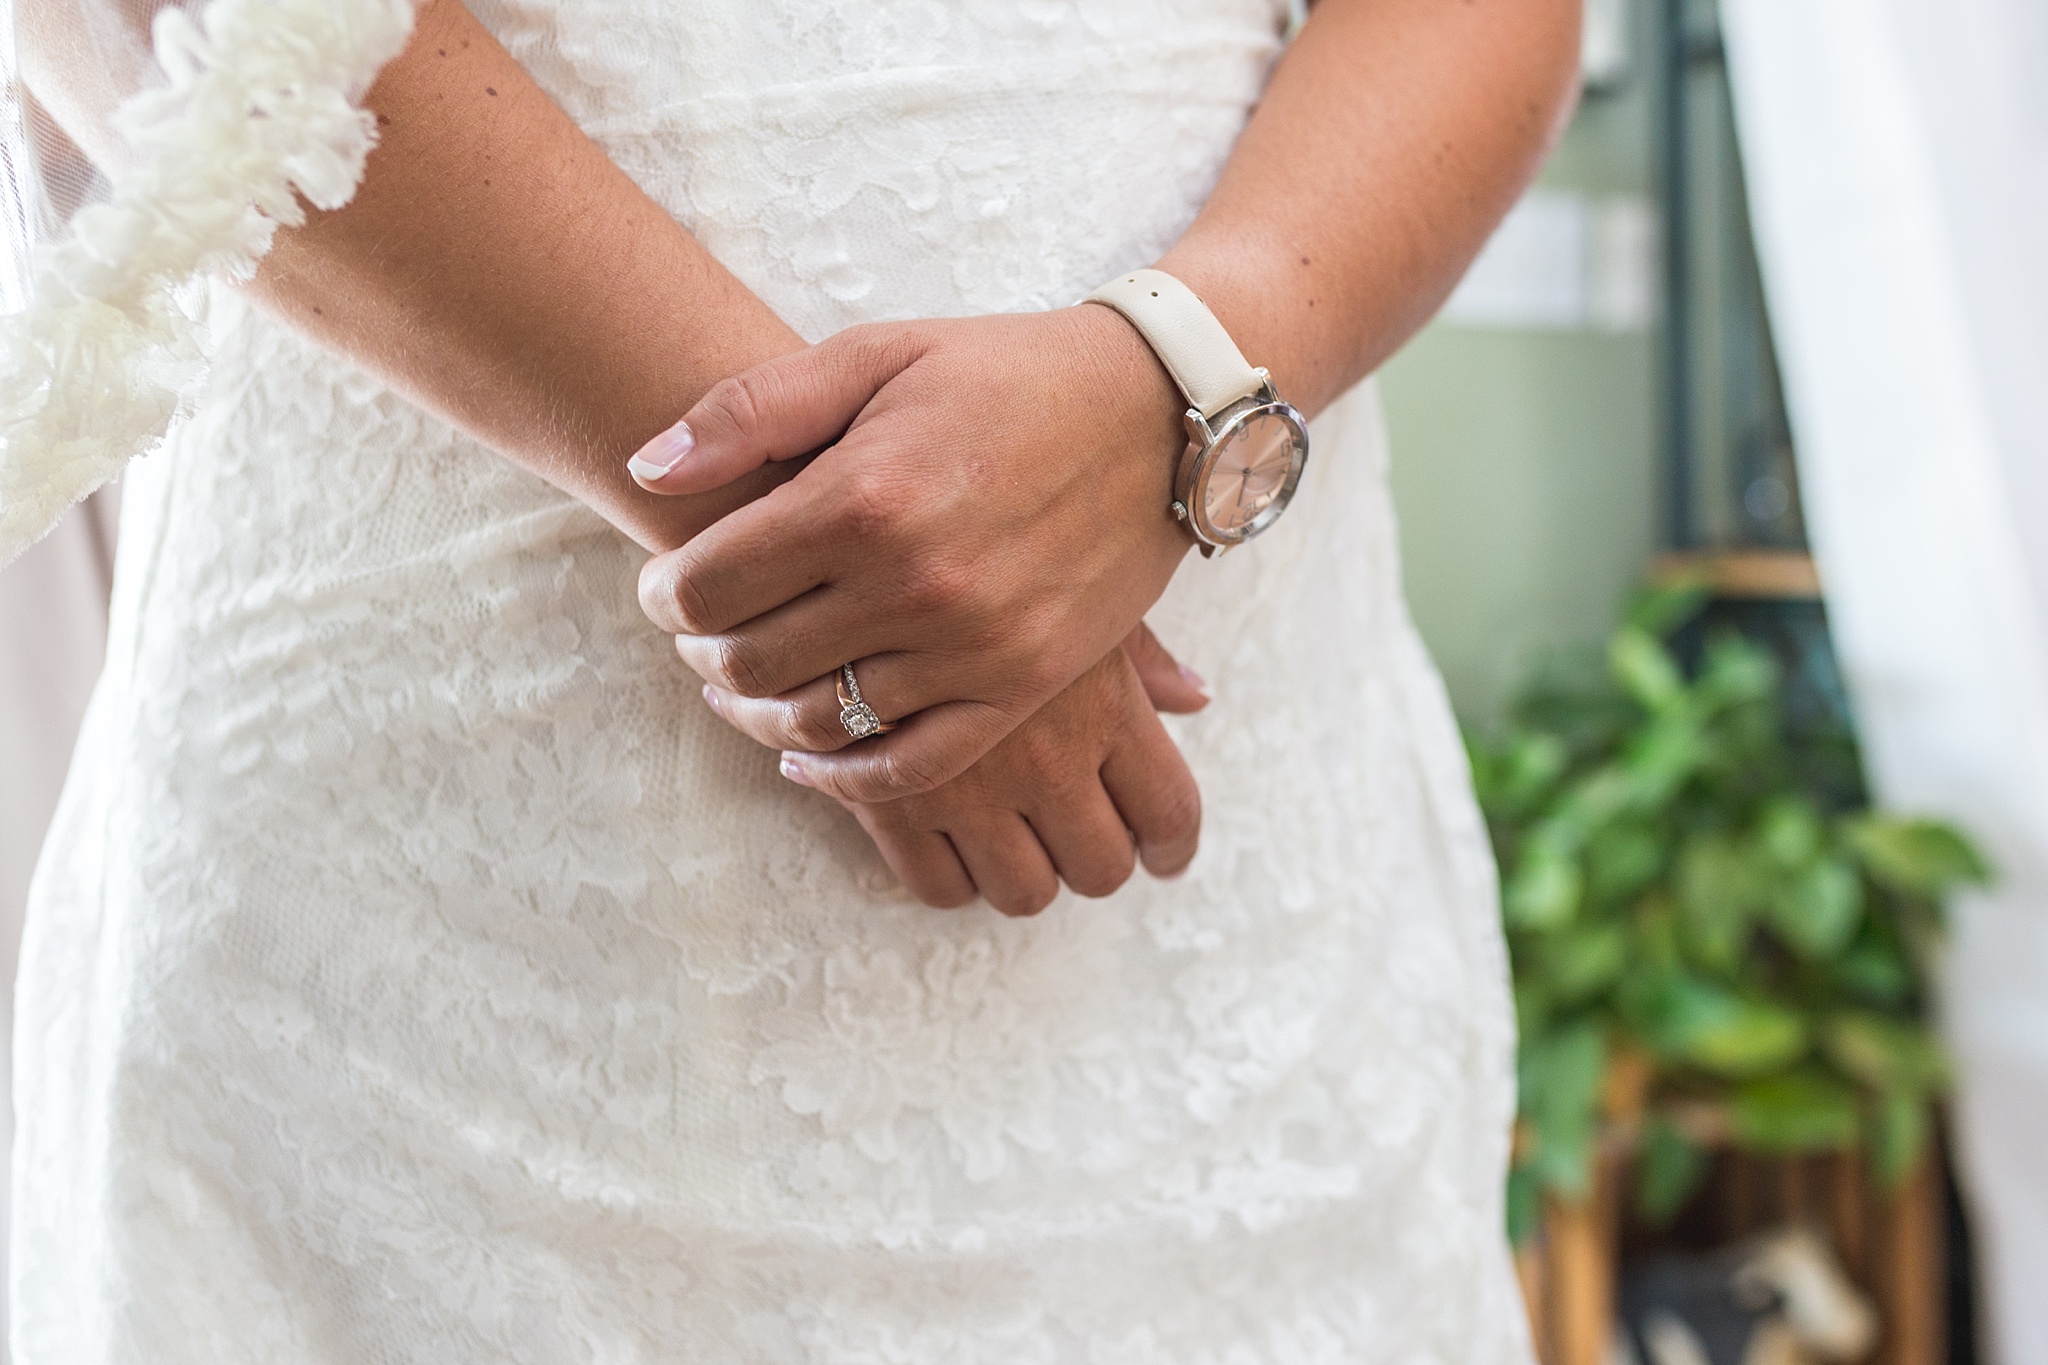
xmin=633 ymin=305 xmax=1190 ymax=802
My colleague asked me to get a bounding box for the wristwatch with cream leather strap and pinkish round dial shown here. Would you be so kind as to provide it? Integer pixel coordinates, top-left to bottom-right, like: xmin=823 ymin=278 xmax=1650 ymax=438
xmin=1087 ymin=270 xmax=1309 ymax=555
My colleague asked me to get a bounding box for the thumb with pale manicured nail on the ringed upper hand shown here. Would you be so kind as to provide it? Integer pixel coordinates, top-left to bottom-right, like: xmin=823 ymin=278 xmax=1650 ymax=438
xmin=627 ymin=327 xmax=922 ymax=493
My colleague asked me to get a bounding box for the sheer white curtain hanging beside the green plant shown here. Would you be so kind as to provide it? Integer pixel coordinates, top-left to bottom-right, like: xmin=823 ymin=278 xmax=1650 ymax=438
xmin=1722 ymin=0 xmax=2048 ymax=1365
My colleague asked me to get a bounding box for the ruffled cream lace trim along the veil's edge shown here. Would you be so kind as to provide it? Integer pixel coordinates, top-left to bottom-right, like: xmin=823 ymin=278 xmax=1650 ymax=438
xmin=0 ymin=0 xmax=416 ymax=565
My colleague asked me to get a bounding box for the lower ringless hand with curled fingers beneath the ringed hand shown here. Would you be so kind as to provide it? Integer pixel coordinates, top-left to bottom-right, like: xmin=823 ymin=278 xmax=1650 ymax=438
xmin=761 ymin=626 xmax=1206 ymax=915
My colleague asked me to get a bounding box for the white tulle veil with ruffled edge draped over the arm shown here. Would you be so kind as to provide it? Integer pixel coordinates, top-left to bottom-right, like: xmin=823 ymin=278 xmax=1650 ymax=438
xmin=0 ymin=0 xmax=416 ymax=565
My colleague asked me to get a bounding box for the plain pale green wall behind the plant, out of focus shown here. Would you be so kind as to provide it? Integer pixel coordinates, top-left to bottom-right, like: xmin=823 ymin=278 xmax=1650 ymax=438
xmin=1382 ymin=6 xmax=1661 ymax=722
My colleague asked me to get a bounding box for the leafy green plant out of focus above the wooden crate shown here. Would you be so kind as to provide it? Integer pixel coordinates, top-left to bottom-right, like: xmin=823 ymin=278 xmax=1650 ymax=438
xmin=1468 ymin=587 xmax=1987 ymax=1242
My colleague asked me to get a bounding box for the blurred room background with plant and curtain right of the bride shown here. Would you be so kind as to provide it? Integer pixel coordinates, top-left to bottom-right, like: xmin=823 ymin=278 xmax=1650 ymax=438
xmin=1382 ymin=0 xmax=2048 ymax=1365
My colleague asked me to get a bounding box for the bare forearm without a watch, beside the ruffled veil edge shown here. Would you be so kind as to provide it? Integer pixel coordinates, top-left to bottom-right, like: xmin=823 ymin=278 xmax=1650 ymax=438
xmin=250 ymin=0 xmax=803 ymax=548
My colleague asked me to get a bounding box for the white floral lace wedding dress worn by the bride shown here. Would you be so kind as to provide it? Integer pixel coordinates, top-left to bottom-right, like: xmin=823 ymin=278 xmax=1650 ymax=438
xmin=12 ymin=0 xmax=1528 ymax=1365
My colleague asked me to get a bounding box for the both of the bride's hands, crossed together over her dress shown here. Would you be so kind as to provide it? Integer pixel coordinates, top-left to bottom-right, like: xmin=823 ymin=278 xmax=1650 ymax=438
xmin=633 ymin=305 xmax=1206 ymax=913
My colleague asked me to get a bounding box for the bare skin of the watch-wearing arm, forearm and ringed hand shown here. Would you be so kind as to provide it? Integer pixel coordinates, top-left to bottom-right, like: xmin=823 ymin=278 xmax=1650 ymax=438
xmin=641 ymin=0 xmax=1579 ymax=802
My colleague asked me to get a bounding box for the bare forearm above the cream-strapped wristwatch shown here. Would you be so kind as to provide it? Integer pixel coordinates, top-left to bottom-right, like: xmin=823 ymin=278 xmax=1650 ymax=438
xmin=1159 ymin=0 xmax=1579 ymax=413
